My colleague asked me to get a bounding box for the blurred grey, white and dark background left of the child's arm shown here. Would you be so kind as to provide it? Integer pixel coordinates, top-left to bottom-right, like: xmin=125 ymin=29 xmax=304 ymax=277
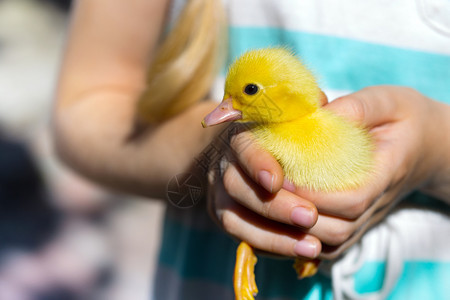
xmin=0 ymin=0 xmax=164 ymax=300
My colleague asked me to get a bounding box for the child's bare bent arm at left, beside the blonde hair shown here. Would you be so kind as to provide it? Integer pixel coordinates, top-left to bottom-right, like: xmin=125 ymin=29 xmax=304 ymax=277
xmin=53 ymin=0 xmax=220 ymax=197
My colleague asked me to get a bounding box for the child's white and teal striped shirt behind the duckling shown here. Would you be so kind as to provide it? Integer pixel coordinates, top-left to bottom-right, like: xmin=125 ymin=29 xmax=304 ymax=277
xmin=153 ymin=0 xmax=450 ymax=300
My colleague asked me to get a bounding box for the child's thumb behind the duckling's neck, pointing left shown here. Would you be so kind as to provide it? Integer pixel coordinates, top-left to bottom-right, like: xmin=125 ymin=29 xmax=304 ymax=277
xmin=324 ymin=86 xmax=399 ymax=128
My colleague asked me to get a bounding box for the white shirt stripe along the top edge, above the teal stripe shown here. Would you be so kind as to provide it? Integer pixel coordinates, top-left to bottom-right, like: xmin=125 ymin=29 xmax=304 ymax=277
xmin=225 ymin=0 xmax=450 ymax=54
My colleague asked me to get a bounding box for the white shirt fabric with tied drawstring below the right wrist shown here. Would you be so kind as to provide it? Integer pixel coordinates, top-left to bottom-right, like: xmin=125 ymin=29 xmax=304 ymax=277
xmin=332 ymin=208 xmax=450 ymax=300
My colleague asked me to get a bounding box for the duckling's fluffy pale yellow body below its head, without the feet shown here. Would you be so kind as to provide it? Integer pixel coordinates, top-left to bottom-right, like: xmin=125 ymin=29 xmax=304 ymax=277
xmin=253 ymin=111 xmax=373 ymax=191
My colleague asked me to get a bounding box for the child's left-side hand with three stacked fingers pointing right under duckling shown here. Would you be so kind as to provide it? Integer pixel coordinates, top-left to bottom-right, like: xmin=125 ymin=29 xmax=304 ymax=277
xmin=209 ymin=132 xmax=321 ymax=258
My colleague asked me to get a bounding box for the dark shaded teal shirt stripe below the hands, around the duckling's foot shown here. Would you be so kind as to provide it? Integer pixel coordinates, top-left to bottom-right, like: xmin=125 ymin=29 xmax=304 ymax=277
xmin=159 ymin=212 xmax=332 ymax=299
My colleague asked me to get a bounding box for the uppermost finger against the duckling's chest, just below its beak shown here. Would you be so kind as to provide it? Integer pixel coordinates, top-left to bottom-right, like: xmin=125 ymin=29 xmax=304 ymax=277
xmin=230 ymin=132 xmax=283 ymax=193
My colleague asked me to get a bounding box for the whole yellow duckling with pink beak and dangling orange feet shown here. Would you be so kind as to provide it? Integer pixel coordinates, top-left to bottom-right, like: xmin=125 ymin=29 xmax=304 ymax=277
xmin=202 ymin=48 xmax=373 ymax=299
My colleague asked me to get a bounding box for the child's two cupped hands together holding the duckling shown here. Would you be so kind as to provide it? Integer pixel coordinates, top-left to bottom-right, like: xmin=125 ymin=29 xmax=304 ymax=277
xmin=209 ymin=86 xmax=450 ymax=258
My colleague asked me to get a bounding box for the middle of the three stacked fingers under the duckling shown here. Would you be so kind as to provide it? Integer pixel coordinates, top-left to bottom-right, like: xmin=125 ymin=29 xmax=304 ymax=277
xmin=223 ymin=164 xmax=317 ymax=228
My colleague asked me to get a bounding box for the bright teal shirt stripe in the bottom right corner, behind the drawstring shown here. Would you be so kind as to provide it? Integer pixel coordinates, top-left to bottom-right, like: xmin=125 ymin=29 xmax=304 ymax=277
xmin=354 ymin=261 xmax=450 ymax=299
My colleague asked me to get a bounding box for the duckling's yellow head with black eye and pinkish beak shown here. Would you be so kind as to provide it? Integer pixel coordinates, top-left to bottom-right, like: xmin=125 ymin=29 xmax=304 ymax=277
xmin=202 ymin=48 xmax=323 ymax=127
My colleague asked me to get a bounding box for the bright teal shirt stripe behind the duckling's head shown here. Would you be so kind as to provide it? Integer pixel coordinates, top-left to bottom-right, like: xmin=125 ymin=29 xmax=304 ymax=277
xmin=229 ymin=27 xmax=450 ymax=103
